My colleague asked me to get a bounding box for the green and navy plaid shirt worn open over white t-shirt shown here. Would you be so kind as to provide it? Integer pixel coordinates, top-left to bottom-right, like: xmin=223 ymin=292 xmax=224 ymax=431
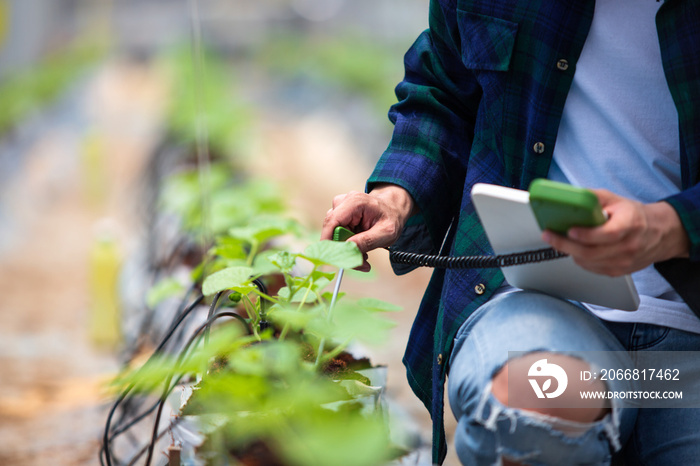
xmin=368 ymin=0 xmax=700 ymax=462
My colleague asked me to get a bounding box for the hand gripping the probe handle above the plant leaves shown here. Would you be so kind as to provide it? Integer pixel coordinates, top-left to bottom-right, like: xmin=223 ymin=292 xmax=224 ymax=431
xmin=321 ymin=184 xmax=414 ymax=272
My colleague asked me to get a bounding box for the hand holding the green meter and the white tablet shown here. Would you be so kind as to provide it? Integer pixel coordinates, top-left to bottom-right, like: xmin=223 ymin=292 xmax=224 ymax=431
xmin=542 ymin=189 xmax=690 ymax=276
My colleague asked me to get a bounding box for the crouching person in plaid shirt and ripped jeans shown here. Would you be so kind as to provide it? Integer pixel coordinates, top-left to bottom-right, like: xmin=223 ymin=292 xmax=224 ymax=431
xmin=322 ymin=0 xmax=700 ymax=465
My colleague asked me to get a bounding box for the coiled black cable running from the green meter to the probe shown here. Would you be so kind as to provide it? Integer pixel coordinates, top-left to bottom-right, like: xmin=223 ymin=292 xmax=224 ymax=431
xmin=388 ymin=248 xmax=567 ymax=269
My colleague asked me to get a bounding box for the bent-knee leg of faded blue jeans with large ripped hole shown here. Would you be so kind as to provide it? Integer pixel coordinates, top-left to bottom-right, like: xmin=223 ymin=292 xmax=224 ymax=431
xmin=448 ymin=291 xmax=638 ymax=466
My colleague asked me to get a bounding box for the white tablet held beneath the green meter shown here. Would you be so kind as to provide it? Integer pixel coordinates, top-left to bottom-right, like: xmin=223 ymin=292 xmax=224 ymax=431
xmin=472 ymin=183 xmax=639 ymax=311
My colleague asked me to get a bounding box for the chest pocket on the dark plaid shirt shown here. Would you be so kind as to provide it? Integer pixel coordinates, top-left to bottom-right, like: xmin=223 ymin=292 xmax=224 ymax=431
xmin=457 ymin=10 xmax=518 ymax=71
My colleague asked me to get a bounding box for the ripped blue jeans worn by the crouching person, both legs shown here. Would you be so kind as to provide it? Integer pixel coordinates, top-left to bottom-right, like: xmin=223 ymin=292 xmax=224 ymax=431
xmin=448 ymin=291 xmax=700 ymax=466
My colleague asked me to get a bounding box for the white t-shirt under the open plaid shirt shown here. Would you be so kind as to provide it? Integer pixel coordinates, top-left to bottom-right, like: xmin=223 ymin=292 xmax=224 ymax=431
xmin=548 ymin=0 xmax=700 ymax=333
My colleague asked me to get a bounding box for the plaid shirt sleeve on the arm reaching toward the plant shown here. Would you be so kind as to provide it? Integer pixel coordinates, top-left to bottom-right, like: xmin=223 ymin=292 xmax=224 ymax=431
xmin=367 ymin=0 xmax=481 ymax=247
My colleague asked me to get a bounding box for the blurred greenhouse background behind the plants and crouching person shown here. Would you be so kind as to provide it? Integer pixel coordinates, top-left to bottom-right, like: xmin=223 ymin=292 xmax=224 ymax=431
xmin=0 ymin=0 xmax=454 ymax=465
